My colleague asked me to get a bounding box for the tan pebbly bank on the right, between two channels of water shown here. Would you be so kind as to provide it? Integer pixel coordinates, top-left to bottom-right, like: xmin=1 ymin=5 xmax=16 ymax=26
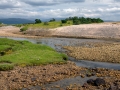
xmin=65 ymin=43 xmax=120 ymax=63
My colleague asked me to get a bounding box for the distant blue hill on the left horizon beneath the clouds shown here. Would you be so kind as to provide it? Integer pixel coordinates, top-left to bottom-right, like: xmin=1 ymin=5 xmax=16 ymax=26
xmin=0 ymin=18 xmax=34 ymax=24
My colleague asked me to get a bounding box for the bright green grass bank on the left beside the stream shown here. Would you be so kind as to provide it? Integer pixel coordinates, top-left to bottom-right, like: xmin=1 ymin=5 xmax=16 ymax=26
xmin=0 ymin=38 xmax=67 ymax=70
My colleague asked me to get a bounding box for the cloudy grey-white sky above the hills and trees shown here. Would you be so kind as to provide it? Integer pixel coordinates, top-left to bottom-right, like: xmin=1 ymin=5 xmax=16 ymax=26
xmin=0 ymin=0 xmax=120 ymax=21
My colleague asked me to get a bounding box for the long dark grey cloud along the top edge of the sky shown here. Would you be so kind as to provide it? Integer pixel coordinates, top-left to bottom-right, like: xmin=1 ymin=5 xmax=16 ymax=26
xmin=22 ymin=0 xmax=85 ymax=6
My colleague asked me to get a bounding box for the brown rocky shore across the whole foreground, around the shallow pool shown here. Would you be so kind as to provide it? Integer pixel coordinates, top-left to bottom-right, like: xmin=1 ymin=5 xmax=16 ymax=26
xmin=0 ymin=61 xmax=120 ymax=90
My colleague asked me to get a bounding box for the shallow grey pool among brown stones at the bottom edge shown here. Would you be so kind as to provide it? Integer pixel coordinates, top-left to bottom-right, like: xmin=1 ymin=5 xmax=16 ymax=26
xmin=22 ymin=76 xmax=96 ymax=90
